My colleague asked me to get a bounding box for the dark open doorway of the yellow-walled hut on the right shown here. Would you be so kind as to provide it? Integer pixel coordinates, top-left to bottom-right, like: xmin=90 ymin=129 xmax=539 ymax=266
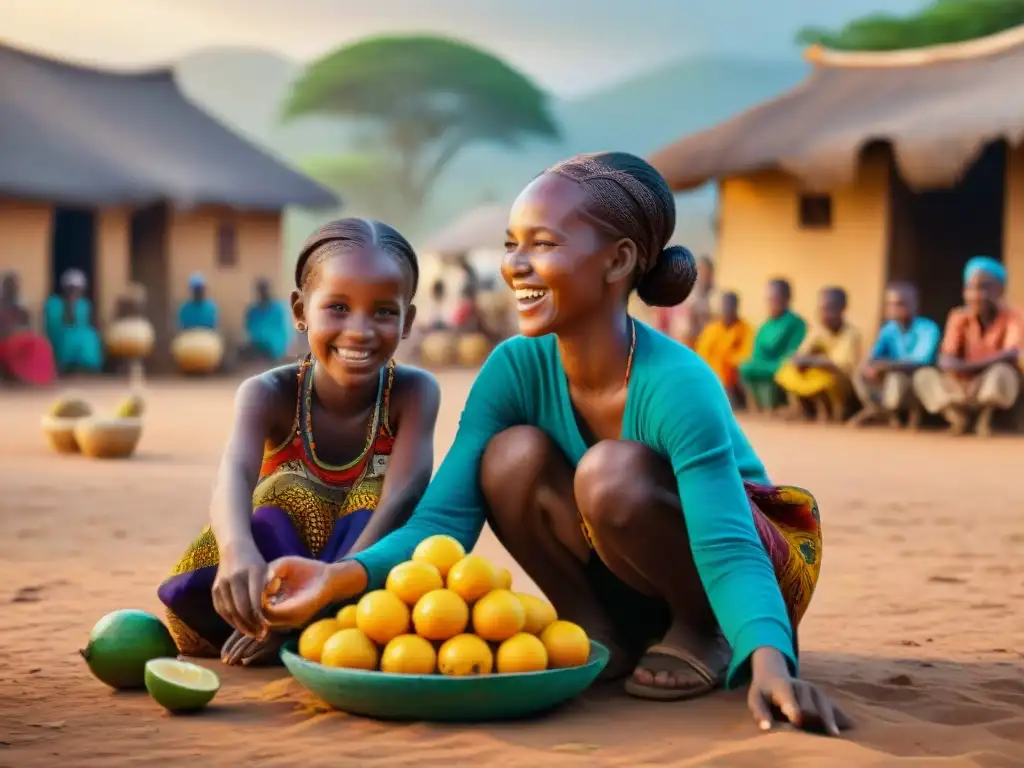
xmin=888 ymin=141 xmax=1008 ymax=325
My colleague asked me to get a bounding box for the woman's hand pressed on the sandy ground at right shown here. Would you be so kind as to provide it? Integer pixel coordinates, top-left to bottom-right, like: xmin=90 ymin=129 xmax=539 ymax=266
xmin=746 ymin=648 xmax=853 ymax=736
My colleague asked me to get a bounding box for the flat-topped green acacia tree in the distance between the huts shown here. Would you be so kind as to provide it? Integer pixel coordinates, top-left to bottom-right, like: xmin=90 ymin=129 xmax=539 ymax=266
xmin=285 ymin=36 xmax=559 ymax=217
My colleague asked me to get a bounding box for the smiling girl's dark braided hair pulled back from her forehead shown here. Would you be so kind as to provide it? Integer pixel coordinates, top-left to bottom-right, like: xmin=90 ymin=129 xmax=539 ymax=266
xmin=295 ymin=218 xmax=420 ymax=300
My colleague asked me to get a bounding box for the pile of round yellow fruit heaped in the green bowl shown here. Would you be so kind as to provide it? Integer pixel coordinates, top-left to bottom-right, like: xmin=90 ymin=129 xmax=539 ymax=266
xmin=299 ymin=536 xmax=590 ymax=677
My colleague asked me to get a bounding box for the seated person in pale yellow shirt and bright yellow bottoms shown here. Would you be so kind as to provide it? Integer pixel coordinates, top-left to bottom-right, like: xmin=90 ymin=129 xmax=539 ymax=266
xmin=775 ymin=288 xmax=860 ymax=421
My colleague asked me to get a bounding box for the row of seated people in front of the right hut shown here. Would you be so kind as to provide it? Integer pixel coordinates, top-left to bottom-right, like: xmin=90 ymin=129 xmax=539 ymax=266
xmin=680 ymin=256 xmax=1024 ymax=435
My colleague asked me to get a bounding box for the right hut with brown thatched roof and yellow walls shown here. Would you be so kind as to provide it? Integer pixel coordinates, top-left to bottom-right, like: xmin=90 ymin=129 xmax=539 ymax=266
xmin=651 ymin=28 xmax=1024 ymax=331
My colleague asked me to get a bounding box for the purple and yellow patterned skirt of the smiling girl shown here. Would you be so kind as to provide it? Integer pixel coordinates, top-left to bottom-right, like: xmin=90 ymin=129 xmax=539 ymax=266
xmin=157 ymin=506 xmax=373 ymax=656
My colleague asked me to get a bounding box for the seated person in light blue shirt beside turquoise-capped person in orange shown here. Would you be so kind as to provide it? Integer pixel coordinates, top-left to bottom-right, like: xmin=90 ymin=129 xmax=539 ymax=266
xmin=850 ymin=283 xmax=942 ymax=428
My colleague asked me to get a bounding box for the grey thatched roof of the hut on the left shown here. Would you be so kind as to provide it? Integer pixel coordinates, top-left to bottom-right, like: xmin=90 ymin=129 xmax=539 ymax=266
xmin=0 ymin=45 xmax=338 ymax=210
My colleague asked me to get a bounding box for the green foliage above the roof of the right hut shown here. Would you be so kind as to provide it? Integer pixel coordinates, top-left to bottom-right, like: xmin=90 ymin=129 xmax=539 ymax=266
xmin=797 ymin=0 xmax=1024 ymax=51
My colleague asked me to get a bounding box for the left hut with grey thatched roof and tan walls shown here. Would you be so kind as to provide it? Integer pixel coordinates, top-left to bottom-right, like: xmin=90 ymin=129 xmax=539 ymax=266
xmin=0 ymin=45 xmax=338 ymax=352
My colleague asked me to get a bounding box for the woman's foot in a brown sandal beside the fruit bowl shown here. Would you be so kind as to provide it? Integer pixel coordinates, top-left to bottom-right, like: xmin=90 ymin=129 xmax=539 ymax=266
xmin=626 ymin=623 xmax=732 ymax=700
